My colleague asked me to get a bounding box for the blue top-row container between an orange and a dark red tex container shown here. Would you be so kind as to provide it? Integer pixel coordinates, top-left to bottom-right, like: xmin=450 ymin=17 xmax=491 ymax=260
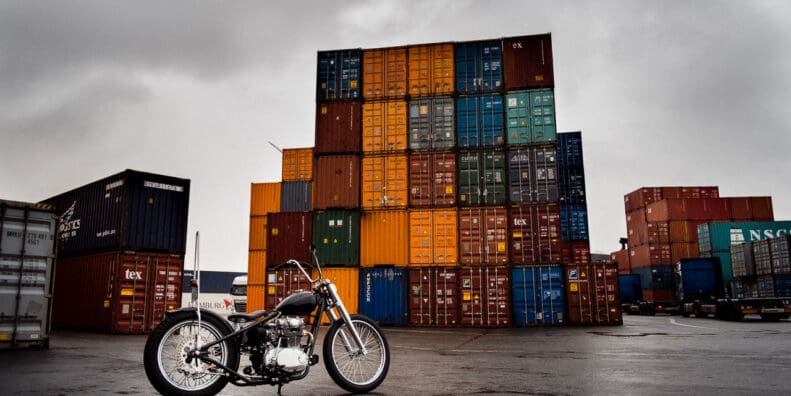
xmin=454 ymin=40 xmax=503 ymax=94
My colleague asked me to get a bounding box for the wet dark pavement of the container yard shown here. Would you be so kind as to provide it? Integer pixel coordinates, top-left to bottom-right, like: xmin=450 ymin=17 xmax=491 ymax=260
xmin=0 ymin=316 xmax=791 ymax=395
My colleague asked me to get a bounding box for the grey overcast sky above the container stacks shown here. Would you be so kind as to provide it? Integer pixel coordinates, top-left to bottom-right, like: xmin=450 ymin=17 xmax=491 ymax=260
xmin=0 ymin=0 xmax=791 ymax=271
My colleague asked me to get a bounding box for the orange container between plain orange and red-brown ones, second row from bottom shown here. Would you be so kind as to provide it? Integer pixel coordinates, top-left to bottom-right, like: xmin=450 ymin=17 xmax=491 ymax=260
xmin=409 ymin=209 xmax=459 ymax=267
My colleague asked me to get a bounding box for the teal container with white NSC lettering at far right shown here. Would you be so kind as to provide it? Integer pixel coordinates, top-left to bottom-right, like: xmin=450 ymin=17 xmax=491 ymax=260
xmin=698 ymin=221 xmax=791 ymax=283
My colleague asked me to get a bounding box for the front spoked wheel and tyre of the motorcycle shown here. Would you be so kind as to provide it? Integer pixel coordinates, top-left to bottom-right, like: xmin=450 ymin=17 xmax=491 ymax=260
xmin=323 ymin=315 xmax=390 ymax=393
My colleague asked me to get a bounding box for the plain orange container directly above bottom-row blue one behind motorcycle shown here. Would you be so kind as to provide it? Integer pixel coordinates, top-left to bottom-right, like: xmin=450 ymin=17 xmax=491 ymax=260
xmin=360 ymin=210 xmax=409 ymax=267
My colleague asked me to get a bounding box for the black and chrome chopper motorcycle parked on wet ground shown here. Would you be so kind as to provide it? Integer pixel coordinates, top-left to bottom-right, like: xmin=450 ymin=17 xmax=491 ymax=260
xmin=143 ymin=249 xmax=390 ymax=395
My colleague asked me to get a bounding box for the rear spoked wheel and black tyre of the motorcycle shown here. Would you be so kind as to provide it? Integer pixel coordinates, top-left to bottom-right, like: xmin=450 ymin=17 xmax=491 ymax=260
xmin=143 ymin=311 xmax=239 ymax=396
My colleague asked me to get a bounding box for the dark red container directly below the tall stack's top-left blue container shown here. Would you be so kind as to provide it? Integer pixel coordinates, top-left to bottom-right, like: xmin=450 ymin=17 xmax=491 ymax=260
xmin=313 ymin=102 xmax=362 ymax=154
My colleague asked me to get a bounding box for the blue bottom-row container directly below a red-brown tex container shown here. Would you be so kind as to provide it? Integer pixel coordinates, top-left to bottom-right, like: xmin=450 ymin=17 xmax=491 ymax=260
xmin=511 ymin=266 xmax=566 ymax=326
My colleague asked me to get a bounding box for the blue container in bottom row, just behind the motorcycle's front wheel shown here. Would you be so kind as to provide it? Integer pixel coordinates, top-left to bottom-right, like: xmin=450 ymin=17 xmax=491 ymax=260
xmin=359 ymin=268 xmax=409 ymax=326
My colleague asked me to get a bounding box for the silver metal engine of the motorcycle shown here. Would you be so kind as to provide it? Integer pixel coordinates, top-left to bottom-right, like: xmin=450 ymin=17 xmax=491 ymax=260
xmin=264 ymin=316 xmax=310 ymax=374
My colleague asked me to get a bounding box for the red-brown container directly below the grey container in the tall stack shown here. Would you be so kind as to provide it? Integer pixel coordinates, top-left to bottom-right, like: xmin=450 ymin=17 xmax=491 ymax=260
xmin=409 ymin=151 xmax=457 ymax=207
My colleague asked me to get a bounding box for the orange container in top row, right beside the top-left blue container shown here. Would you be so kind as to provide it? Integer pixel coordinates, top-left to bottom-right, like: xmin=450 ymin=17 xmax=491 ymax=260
xmin=363 ymin=47 xmax=407 ymax=100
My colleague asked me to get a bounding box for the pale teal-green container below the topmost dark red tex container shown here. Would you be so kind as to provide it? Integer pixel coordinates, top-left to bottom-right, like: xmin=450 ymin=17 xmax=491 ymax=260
xmin=505 ymin=89 xmax=557 ymax=145
